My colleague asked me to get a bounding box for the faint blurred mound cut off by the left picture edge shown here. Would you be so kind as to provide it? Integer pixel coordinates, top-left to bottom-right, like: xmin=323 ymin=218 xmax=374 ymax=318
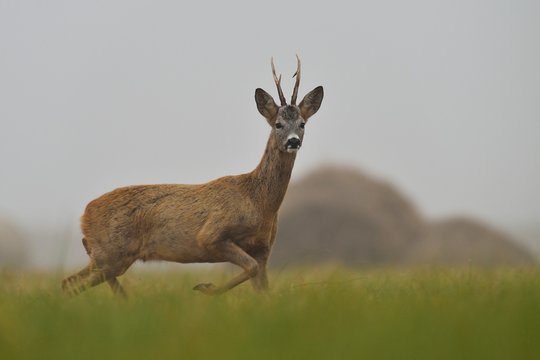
xmin=0 ymin=219 xmax=28 ymax=269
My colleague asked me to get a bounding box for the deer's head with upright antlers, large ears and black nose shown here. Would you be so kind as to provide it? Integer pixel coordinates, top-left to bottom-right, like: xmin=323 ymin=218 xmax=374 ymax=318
xmin=255 ymin=55 xmax=324 ymax=153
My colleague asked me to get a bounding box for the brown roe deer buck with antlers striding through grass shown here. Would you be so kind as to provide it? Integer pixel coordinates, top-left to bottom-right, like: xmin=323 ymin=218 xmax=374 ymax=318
xmin=62 ymin=56 xmax=323 ymax=296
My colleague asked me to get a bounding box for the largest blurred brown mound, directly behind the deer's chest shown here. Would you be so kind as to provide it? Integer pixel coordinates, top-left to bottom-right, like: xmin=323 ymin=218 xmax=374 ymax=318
xmin=271 ymin=167 xmax=426 ymax=265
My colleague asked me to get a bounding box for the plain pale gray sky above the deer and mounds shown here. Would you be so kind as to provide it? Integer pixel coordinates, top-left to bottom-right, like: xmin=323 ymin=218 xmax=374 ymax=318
xmin=0 ymin=0 xmax=540 ymax=264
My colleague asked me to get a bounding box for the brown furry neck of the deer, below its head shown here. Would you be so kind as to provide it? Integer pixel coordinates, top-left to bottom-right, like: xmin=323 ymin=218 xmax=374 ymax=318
xmin=249 ymin=135 xmax=296 ymax=213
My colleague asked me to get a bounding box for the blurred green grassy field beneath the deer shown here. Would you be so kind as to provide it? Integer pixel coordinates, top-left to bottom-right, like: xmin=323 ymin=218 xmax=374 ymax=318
xmin=0 ymin=268 xmax=540 ymax=359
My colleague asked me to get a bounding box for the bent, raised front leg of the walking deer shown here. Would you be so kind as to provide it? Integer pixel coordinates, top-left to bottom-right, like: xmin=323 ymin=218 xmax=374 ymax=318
xmin=193 ymin=241 xmax=259 ymax=295
